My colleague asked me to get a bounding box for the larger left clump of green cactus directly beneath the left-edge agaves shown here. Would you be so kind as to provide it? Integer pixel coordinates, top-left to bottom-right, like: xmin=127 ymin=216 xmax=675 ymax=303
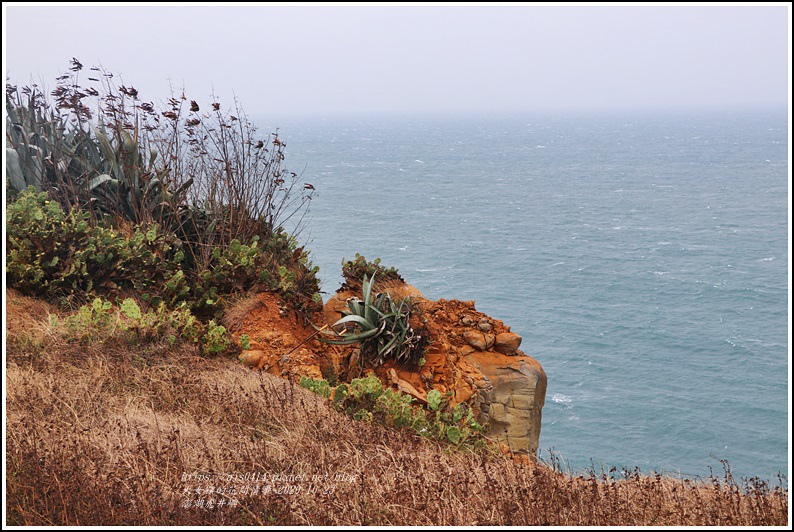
xmin=6 ymin=187 xmax=189 ymax=302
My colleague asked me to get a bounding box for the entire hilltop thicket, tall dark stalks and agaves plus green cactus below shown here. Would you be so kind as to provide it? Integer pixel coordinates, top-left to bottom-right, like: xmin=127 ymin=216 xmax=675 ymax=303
xmin=6 ymin=59 xmax=320 ymax=323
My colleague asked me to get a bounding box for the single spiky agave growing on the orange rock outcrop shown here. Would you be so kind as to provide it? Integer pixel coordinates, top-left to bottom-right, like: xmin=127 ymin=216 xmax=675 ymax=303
xmin=319 ymin=274 xmax=422 ymax=366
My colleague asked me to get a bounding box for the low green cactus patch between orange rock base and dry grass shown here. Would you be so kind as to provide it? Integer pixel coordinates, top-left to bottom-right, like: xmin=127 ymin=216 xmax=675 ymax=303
xmin=300 ymin=375 xmax=488 ymax=449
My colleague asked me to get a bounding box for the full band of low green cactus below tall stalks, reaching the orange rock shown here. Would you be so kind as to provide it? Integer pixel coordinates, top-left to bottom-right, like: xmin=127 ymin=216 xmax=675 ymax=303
xmin=6 ymin=187 xmax=319 ymax=319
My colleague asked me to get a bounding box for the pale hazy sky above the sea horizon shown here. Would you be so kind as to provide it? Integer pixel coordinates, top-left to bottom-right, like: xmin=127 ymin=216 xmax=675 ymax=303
xmin=3 ymin=3 xmax=791 ymax=115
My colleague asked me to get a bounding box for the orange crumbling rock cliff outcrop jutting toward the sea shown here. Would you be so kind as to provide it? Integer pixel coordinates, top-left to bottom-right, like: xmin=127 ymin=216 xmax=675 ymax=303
xmin=230 ymin=281 xmax=546 ymax=456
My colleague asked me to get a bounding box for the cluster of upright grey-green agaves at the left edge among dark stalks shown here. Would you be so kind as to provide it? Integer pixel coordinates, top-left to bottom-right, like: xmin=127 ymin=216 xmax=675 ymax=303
xmin=6 ymin=73 xmax=193 ymax=230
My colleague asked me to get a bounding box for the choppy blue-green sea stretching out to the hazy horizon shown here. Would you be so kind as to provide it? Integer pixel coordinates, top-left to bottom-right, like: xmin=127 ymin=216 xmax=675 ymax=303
xmin=258 ymin=110 xmax=790 ymax=480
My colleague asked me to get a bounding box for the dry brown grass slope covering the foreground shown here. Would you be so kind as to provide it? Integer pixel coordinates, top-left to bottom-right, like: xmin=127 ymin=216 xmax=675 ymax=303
xmin=6 ymin=292 xmax=788 ymax=526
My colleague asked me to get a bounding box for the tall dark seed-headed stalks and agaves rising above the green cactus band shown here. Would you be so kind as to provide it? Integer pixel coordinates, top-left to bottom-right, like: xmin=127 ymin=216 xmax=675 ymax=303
xmin=6 ymin=59 xmax=314 ymax=251
